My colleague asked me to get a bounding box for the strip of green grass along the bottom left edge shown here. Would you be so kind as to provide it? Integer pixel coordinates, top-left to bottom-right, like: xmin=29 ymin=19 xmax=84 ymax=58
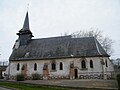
xmin=0 ymin=82 xmax=69 ymax=90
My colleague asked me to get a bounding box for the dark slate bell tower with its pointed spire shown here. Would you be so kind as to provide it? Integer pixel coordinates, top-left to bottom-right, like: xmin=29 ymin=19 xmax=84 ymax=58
xmin=16 ymin=12 xmax=34 ymax=46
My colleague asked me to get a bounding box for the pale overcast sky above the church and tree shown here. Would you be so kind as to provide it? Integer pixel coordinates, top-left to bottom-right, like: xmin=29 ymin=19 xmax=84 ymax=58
xmin=0 ymin=0 xmax=120 ymax=61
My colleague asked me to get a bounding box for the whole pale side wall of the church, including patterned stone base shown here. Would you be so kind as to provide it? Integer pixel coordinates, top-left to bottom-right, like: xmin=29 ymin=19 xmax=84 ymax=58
xmin=6 ymin=57 xmax=114 ymax=79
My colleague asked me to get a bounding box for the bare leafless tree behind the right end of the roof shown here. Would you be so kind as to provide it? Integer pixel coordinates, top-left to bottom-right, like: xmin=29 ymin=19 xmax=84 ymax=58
xmin=71 ymin=28 xmax=113 ymax=55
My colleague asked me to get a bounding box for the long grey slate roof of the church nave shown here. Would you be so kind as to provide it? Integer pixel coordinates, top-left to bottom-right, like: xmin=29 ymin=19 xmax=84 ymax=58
xmin=9 ymin=36 xmax=109 ymax=60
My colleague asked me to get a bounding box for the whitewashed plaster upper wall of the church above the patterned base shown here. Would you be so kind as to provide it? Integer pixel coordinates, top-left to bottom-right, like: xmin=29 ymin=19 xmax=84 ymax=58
xmin=6 ymin=57 xmax=114 ymax=76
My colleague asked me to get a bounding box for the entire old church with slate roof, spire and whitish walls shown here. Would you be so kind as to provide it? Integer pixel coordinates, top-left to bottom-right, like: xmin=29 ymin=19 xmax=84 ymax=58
xmin=6 ymin=12 xmax=114 ymax=80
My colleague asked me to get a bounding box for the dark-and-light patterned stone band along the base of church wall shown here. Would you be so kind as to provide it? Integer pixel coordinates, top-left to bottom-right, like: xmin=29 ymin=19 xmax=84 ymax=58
xmin=5 ymin=73 xmax=113 ymax=80
